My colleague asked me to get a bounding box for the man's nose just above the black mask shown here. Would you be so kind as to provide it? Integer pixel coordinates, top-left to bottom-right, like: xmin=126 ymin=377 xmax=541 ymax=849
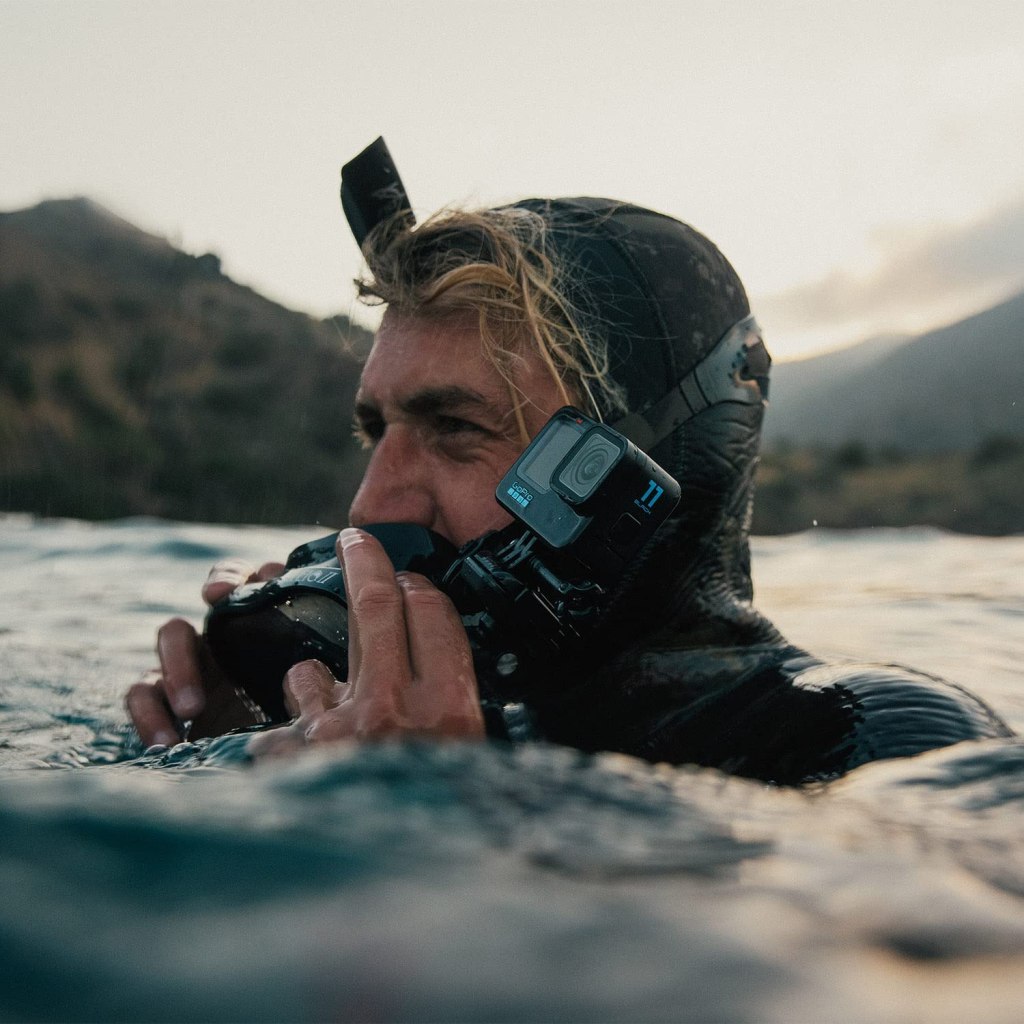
xmin=348 ymin=426 xmax=435 ymax=527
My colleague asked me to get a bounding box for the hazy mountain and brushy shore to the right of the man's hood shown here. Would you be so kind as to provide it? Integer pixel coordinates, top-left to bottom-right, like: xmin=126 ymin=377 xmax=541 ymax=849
xmin=754 ymin=294 xmax=1024 ymax=535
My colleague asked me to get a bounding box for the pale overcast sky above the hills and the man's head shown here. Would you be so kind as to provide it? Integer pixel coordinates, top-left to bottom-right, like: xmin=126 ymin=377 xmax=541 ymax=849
xmin=0 ymin=0 xmax=1024 ymax=359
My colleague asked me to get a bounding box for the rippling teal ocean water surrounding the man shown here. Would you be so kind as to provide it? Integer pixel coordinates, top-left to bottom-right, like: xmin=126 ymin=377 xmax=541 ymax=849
xmin=0 ymin=516 xmax=1024 ymax=1024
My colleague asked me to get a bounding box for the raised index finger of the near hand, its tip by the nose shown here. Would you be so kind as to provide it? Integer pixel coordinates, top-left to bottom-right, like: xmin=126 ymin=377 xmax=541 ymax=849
xmin=337 ymin=528 xmax=411 ymax=691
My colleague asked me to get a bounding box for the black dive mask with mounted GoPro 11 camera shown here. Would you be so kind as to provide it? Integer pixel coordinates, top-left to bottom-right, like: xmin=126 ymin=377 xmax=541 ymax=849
xmin=205 ymin=407 xmax=679 ymax=721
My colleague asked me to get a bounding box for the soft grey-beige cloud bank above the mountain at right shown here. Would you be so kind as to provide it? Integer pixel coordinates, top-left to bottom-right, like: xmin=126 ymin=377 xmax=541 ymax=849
xmin=757 ymin=197 xmax=1024 ymax=330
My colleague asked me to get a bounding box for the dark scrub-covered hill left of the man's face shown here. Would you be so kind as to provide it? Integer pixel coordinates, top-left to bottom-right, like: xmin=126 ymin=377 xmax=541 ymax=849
xmin=0 ymin=200 xmax=369 ymax=527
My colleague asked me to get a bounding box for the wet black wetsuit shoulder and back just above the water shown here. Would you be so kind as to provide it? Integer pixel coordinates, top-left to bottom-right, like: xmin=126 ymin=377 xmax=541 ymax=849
xmin=516 ymin=644 xmax=1013 ymax=784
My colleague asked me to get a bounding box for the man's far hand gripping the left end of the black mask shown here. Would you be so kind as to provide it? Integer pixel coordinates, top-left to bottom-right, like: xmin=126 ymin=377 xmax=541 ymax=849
xmin=125 ymin=560 xmax=284 ymax=746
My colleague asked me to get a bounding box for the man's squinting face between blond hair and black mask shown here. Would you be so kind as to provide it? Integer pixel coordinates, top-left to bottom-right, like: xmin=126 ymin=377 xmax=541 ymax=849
xmin=349 ymin=311 xmax=564 ymax=547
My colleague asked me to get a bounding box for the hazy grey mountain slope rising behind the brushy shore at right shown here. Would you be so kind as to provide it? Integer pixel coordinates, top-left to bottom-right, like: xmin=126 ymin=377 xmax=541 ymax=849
xmin=765 ymin=293 xmax=1024 ymax=453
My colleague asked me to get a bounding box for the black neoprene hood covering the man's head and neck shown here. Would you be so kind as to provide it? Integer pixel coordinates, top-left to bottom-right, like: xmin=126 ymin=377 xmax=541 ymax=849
xmin=516 ymin=198 xmax=777 ymax=646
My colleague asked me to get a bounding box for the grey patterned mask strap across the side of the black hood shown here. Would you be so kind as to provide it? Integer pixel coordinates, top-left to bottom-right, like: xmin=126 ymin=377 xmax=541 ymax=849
xmin=609 ymin=316 xmax=771 ymax=452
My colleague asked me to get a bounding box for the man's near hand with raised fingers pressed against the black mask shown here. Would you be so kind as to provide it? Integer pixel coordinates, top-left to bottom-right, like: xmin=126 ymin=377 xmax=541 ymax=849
xmin=249 ymin=529 xmax=483 ymax=757
